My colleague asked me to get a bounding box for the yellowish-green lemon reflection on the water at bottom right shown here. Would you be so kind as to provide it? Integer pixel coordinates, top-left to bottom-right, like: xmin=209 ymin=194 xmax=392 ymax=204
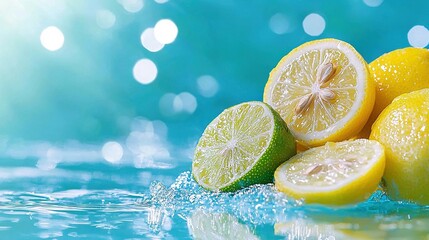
xmin=274 ymin=213 xmax=429 ymax=239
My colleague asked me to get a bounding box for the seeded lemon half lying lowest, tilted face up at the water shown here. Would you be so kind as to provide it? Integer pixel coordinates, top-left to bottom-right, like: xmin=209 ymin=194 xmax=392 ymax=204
xmin=274 ymin=139 xmax=385 ymax=205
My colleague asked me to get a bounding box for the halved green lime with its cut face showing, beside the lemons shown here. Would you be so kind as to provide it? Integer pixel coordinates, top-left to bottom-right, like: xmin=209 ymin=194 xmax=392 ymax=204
xmin=192 ymin=101 xmax=296 ymax=191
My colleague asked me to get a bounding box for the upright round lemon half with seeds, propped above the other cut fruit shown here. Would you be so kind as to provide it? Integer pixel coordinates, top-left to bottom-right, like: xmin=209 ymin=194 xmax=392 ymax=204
xmin=264 ymin=39 xmax=375 ymax=146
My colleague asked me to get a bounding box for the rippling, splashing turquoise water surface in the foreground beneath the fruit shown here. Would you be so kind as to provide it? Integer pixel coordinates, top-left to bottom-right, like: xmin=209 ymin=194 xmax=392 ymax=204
xmin=0 ymin=173 xmax=429 ymax=239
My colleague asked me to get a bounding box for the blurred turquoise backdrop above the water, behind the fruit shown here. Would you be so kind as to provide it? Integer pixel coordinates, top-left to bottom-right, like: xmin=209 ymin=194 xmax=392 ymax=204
xmin=0 ymin=0 xmax=429 ymax=172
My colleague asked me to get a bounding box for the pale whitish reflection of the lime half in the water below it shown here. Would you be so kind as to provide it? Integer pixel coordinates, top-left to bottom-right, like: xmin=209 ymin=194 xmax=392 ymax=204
xmin=187 ymin=210 xmax=259 ymax=240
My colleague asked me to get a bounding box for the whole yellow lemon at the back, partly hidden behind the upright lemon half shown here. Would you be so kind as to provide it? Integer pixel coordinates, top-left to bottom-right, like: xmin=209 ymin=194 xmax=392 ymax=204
xmin=358 ymin=47 xmax=429 ymax=138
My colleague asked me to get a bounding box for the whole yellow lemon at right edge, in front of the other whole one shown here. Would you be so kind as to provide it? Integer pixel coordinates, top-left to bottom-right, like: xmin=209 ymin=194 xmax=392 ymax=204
xmin=370 ymin=89 xmax=429 ymax=204
